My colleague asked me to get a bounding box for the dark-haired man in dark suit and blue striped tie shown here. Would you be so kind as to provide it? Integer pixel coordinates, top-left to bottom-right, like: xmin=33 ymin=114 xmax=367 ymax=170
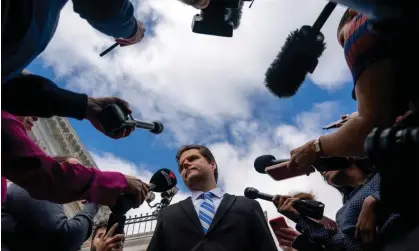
xmin=147 ymin=145 xmax=278 ymax=251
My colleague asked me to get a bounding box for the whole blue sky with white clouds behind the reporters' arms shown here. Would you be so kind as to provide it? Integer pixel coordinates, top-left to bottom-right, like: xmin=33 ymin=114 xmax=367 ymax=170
xmin=29 ymin=0 xmax=356 ymax=247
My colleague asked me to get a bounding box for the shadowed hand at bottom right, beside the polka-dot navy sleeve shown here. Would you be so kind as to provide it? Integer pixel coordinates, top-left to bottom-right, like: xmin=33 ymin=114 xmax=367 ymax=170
xmin=355 ymin=196 xmax=377 ymax=245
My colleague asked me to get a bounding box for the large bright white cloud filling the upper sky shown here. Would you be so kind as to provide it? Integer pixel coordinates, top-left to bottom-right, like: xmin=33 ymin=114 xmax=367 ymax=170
xmin=43 ymin=0 xmax=348 ymax=142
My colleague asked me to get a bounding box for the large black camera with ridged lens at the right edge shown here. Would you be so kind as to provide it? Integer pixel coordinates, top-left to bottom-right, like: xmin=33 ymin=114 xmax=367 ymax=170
xmin=364 ymin=111 xmax=419 ymax=220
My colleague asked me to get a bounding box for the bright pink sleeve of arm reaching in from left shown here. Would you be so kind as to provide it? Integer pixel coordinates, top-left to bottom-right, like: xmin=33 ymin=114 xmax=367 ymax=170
xmin=1 ymin=111 xmax=127 ymax=206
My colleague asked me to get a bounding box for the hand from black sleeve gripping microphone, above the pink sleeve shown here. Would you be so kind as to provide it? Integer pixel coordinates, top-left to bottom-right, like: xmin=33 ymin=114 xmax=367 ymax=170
xmin=86 ymin=97 xmax=134 ymax=139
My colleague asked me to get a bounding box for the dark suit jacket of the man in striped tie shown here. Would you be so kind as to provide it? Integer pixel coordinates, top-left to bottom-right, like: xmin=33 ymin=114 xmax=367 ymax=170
xmin=147 ymin=194 xmax=278 ymax=251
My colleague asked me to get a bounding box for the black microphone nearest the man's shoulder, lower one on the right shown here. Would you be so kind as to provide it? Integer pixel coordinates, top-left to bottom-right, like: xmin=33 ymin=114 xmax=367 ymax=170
xmin=244 ymin=187 xmax=324 ymax=220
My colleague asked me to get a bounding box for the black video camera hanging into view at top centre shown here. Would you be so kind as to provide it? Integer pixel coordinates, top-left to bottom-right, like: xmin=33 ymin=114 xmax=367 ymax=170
xmin=192 ymin=0 xmax=252 ymax=37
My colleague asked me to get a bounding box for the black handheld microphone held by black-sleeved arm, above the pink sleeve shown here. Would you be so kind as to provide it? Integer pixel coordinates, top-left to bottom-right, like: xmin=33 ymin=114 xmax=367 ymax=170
xmin=99 ymin=104 xmax=164 ymax=135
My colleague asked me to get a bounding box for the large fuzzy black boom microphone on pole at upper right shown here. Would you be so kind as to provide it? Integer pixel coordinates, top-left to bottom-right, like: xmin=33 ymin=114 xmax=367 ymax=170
xmin=265 ymin=2 xmax=336 ymax=98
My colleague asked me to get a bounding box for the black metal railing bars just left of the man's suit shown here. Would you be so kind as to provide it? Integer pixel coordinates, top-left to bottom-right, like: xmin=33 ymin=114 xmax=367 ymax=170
xmin=124 ymin=213 xmax=158 ymax=236
